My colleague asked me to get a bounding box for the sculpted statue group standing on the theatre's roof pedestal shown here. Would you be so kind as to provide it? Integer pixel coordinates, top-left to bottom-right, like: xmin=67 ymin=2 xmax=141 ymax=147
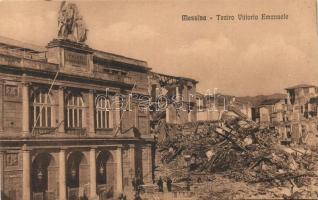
xmin=58 ymin=1 xmax=88 ymax=43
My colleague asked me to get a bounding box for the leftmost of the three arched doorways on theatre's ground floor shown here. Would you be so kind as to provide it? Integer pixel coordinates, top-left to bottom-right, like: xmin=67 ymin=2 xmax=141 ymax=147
xmin=31 ymin=153 xmax=57 ymax=200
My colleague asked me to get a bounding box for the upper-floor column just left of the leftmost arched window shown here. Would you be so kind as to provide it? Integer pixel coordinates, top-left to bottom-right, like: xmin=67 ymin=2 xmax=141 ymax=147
xmin=21 ymin=83 xmax=30 ymax=137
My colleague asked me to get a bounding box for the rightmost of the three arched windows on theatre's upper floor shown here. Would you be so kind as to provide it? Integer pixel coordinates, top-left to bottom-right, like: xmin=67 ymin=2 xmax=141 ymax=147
xmin=95 ymin=96 xmax=113 ymax=129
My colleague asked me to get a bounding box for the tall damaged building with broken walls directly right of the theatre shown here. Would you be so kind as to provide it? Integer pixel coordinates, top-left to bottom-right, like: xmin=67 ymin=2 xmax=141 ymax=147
xmin=149 ymin=72 xmax=198 ymax=124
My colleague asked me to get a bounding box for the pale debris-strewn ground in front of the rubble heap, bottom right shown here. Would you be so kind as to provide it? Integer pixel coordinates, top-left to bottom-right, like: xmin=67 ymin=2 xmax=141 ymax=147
xmin=191 ymin=170 xmax=318 ymax=200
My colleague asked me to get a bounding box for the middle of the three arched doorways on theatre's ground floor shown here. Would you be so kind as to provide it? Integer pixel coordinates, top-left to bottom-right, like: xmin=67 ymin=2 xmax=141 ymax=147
xmin=66 ymin=151 xmax=89 ymax=200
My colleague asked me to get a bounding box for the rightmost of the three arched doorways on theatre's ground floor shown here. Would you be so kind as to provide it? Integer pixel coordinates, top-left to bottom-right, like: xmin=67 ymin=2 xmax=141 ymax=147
xmin=96 ymin=150 xmax=116 ymax=200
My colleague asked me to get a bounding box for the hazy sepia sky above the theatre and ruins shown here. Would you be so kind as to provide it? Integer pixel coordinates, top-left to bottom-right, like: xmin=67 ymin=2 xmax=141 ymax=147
xmin=0 ymin=0 xmax=318 ymax=96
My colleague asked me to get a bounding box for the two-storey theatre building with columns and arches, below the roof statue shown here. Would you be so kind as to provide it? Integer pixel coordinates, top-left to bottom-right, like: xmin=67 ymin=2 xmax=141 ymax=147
xmin=0 ymin=35 xmax=153 ymax=200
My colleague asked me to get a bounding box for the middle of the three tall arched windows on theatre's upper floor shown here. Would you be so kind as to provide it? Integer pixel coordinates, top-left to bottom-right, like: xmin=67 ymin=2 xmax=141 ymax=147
xmin=66 ymin=93 xmax=84 ymax=129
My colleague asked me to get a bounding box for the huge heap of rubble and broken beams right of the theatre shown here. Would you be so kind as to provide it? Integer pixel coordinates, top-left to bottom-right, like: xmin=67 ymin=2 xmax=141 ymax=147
xmin=159 ymin=118 xmax=314 ymax=187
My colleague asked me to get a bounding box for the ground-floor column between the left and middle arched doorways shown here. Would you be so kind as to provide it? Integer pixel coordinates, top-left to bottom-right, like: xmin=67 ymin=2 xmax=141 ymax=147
xmin=59 ymin=149 xmax=66 ymax=200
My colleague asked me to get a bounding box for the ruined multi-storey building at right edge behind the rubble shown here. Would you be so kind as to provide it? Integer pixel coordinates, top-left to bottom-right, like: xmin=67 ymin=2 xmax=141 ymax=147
xmin=253 ymin=84 xmax=318 ymax=145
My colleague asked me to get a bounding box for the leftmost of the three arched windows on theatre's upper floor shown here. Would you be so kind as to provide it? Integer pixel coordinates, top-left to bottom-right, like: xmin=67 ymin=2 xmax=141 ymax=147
xmin=30 ymin=90 xmax=53 ymax=128
